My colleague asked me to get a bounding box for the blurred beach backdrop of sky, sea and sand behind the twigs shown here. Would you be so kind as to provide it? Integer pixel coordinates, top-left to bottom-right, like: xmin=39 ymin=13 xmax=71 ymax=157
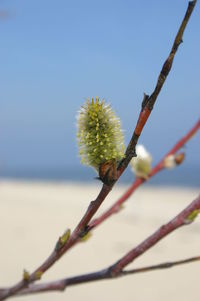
xmin=0 ymin=0 xmax=200 ymax=301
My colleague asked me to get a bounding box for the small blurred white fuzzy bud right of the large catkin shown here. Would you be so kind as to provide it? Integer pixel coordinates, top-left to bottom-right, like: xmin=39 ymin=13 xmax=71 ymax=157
xmin=130 ymin=145 xmax=152 ymax=179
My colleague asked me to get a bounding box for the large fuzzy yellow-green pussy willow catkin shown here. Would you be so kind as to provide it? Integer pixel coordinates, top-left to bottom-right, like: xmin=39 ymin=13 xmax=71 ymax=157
xmin=77 ymin=97 xmax=125 ymax=171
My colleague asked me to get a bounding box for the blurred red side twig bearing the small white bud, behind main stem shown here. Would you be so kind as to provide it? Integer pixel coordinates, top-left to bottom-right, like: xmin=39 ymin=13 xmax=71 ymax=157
xmin=88 ymin=120 xmax=200 ymax=227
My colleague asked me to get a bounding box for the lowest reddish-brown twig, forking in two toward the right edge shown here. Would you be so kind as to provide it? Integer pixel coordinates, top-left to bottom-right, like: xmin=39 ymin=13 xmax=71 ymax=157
xmin=11 ymin=196 xmax=200 ymax=294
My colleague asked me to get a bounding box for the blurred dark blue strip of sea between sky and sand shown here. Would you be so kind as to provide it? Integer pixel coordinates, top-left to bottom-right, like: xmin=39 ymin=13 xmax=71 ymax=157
xmin=0 ymin=165 xmax=200 ymax=187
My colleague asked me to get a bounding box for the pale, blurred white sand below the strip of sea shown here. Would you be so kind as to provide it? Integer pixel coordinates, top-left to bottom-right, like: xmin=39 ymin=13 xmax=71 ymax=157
xmin=0 ymin=181 xmax=200 ymax=301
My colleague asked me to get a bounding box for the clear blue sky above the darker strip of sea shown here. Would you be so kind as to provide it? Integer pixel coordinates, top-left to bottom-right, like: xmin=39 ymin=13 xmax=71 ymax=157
xmin=0 ymin=0 xmax=200 ymax=175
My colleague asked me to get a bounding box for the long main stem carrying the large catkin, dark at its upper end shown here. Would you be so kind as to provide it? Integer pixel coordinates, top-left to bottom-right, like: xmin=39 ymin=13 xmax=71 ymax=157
xmin=0 ymin=0 xmax=196 ymax=300
